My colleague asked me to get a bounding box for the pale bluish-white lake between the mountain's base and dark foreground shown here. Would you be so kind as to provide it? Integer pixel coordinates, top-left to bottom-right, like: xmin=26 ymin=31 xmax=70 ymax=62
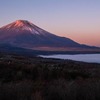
xmin=40 ymin=54 xmax=100 ymax=63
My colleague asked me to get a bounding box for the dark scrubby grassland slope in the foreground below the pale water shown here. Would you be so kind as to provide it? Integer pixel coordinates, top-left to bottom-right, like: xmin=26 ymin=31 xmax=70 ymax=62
xmin=0 ymin=54 xmax=100 ymax=100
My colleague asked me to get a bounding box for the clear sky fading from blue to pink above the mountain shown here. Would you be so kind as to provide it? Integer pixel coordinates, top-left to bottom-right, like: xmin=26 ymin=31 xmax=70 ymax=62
xmin=0 ymin=0 xmax=100 ymax=47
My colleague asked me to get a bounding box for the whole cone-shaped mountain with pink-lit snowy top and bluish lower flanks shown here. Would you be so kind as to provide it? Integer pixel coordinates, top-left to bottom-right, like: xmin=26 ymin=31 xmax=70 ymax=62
xmin=0 ymin=20 xmax=98 ymax=49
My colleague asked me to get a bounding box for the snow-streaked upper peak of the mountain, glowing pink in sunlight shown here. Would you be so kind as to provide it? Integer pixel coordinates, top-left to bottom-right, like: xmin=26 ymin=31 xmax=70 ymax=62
xmin=2 ymin=20 xmax=47 ymax=35
